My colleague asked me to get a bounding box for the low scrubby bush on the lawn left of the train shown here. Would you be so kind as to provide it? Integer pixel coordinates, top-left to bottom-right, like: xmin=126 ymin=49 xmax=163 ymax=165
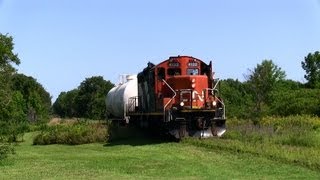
xmin=33 ymin=122 xmax=108 ymax=145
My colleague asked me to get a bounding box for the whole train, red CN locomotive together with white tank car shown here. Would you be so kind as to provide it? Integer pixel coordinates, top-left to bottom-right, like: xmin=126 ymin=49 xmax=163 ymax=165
xmin=106 ymin=56 xmax=226 ymax=139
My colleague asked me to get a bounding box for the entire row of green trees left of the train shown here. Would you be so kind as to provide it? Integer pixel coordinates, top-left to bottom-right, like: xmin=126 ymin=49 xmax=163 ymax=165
xmin=0 ymin=33 xmax=114 ymax=159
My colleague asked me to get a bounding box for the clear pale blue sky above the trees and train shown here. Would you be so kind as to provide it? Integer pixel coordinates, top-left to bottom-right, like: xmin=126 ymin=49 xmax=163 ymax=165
xmin=0 ymin=0 xmax=320 ymax=102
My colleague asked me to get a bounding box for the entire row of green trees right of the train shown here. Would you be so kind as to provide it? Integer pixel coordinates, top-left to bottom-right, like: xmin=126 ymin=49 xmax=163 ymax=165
xmin=220 ymin=51 xmax=320 ymax=122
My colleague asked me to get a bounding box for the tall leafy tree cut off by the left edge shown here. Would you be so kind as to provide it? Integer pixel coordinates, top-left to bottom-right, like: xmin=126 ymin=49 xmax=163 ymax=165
xmin=0 ymin=34 xmax=27 ymax=148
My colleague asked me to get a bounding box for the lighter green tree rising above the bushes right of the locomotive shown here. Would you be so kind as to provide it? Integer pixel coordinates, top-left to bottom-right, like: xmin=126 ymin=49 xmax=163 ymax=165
xmin=246 ymin=60 xmax=286 ymax=119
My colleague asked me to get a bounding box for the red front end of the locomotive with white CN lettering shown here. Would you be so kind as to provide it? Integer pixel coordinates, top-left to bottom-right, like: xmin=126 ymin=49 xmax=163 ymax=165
xmin=155 ymin=56 xmax=225 ymax=137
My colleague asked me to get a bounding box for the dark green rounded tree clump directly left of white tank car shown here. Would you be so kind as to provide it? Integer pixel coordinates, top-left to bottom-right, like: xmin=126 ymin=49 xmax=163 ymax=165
xmin=53 ymin=76 xmax=114 ymax=120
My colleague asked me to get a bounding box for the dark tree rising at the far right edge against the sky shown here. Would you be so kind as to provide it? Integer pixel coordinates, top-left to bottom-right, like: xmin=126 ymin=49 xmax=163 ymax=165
xmin=301 ymin=51 xmax=320 ymax=88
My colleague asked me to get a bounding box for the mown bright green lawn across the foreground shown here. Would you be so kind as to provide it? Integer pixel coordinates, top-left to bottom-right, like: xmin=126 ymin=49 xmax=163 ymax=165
xmin=0 ymin=133 xmax=320 ymax=179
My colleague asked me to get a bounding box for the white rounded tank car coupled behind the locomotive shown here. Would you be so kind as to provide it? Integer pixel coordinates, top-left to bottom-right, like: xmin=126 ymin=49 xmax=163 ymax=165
xmin=106 ymin=75 xmax=138 ymax=120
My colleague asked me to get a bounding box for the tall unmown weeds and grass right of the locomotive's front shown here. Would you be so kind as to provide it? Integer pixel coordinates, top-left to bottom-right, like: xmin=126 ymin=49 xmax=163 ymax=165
xmin=185 ymin=116 xmax=320 ymax=170
